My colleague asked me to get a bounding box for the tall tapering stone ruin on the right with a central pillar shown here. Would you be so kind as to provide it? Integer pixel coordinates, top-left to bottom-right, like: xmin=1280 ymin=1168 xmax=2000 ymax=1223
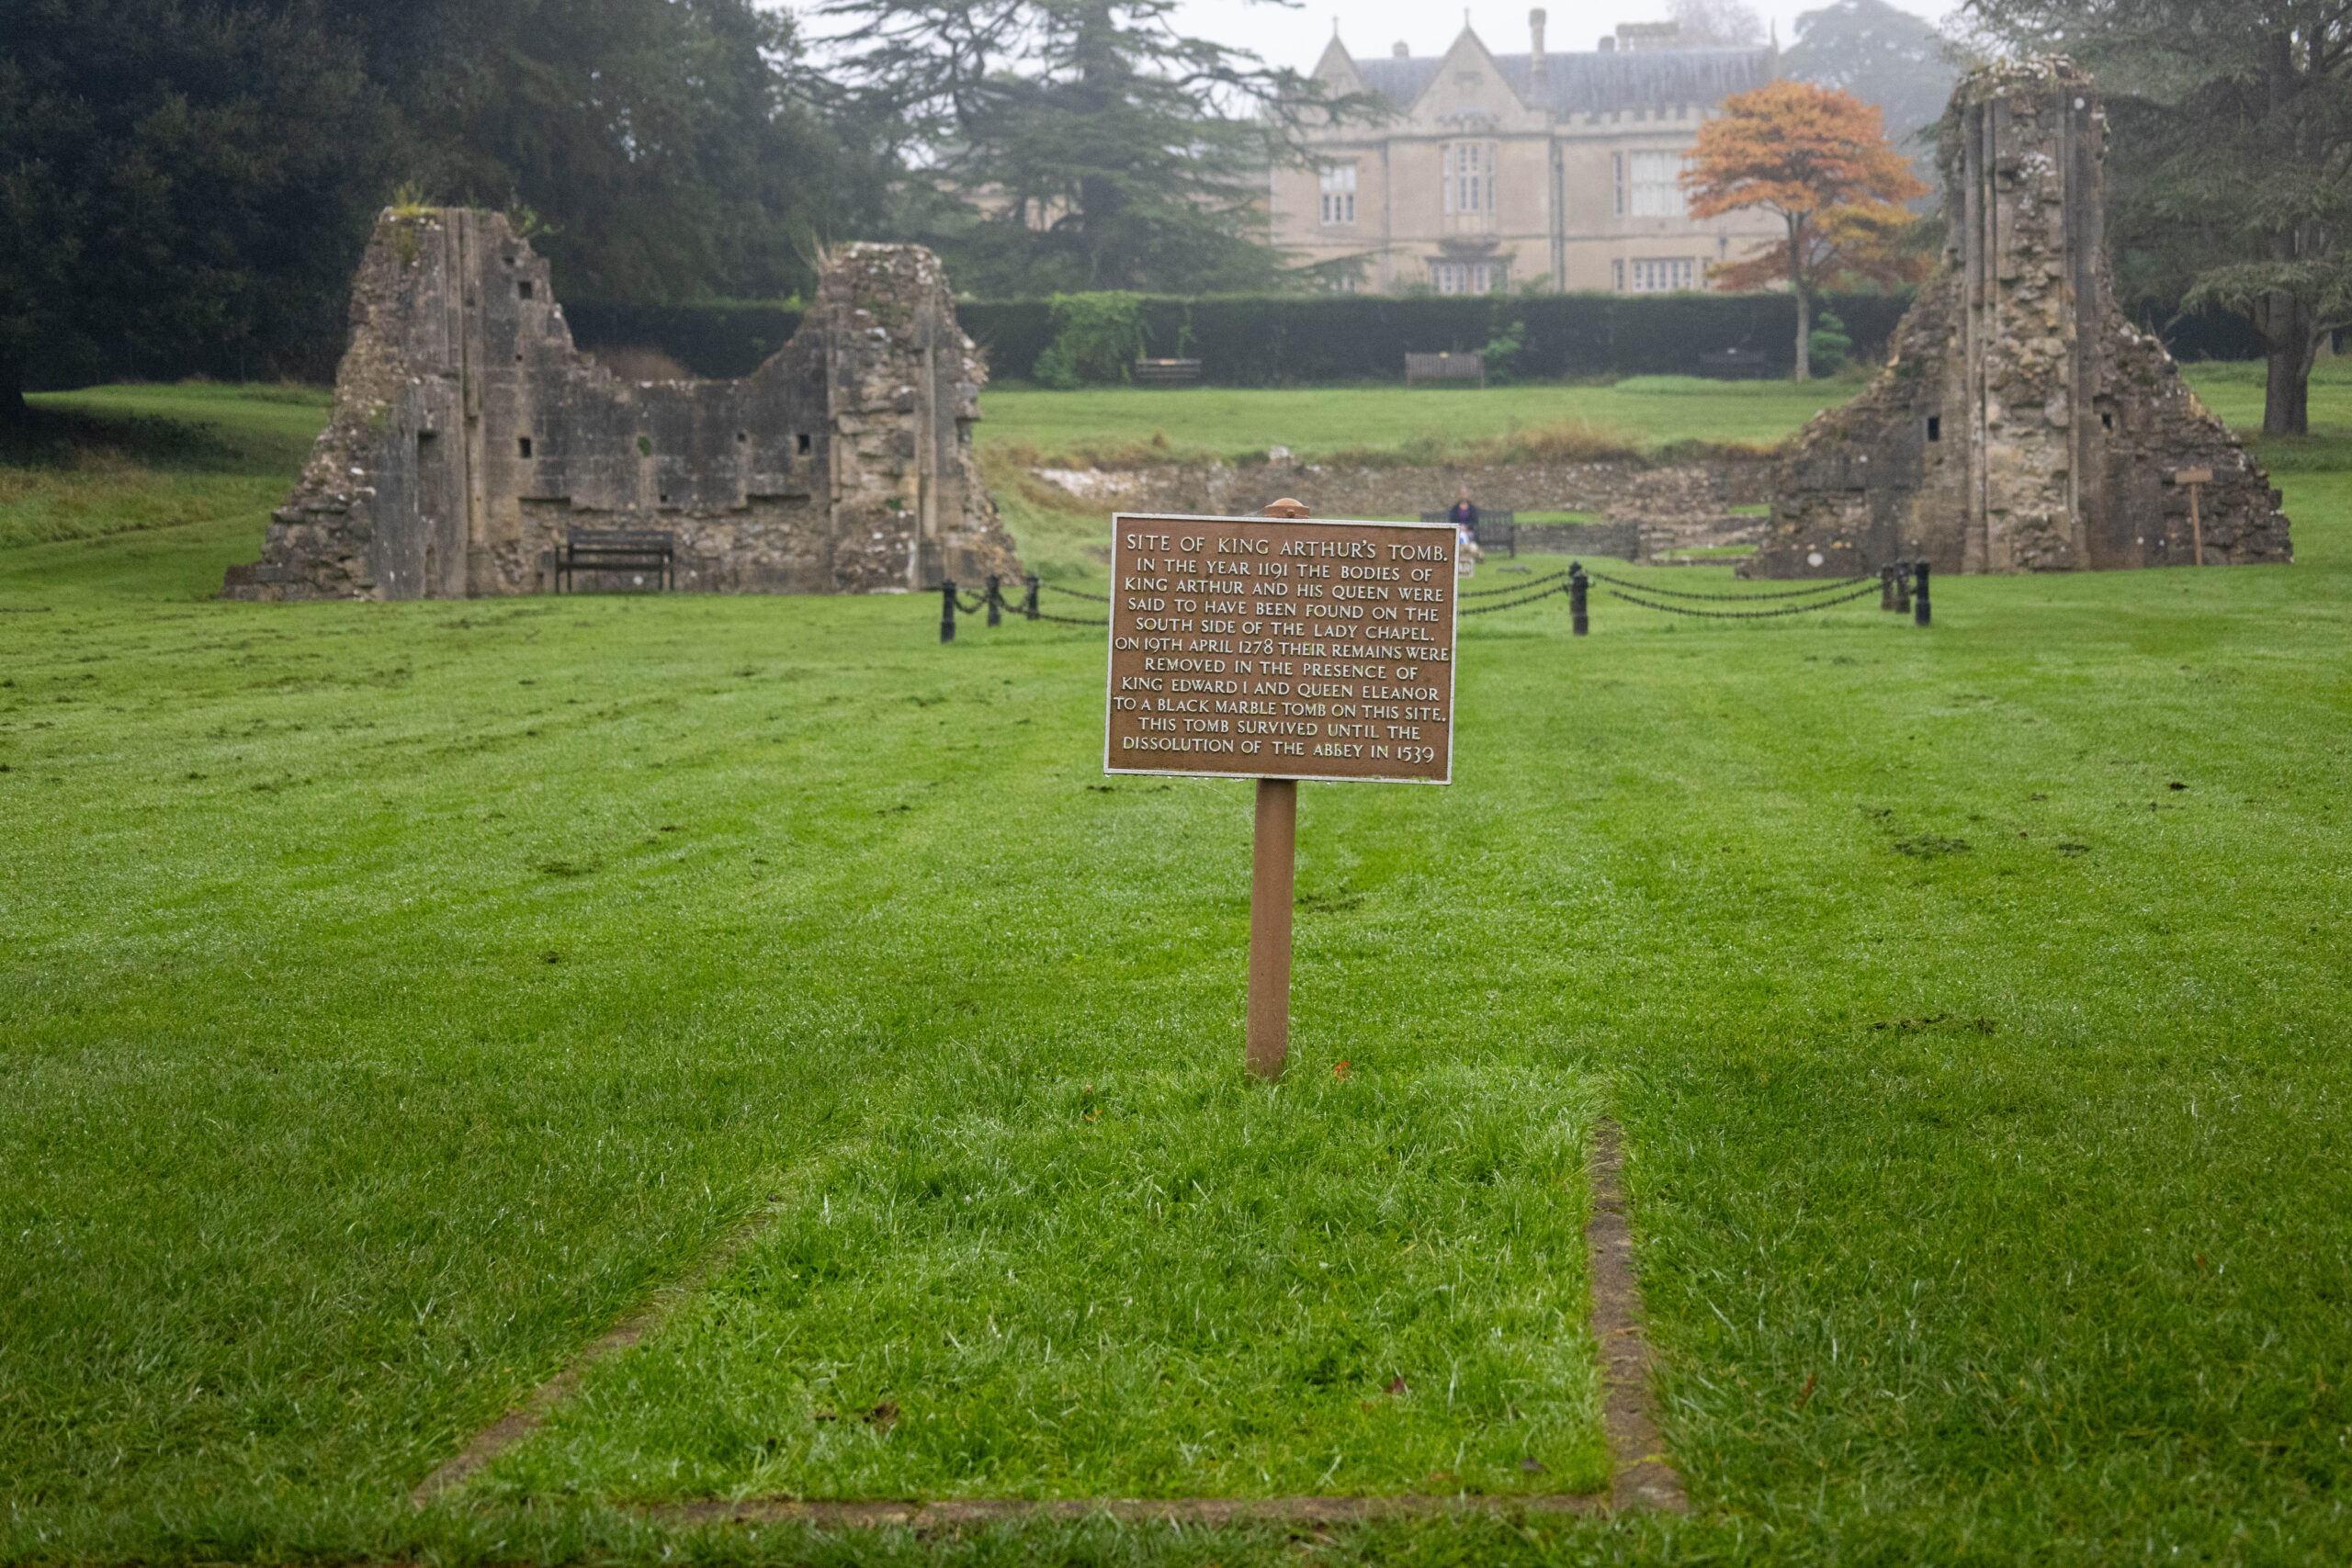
xmin=1750 ymin=59 xmax=2293 ymax=579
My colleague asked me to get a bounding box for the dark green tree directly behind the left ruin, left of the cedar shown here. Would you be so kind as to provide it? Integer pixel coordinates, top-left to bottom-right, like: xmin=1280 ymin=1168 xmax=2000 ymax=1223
xmin=329 ymin=0 xmax=837 ymax=299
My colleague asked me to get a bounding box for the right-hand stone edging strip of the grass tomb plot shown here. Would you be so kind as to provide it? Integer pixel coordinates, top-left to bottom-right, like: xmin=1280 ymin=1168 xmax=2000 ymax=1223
xmin=1585 ymin=1117 xmax=1691 ymax=1514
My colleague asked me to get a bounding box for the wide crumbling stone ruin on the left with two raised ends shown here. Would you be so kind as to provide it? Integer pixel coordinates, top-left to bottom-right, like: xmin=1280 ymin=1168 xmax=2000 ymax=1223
xmin=223 ymin=207 xmax=1021 ymax=600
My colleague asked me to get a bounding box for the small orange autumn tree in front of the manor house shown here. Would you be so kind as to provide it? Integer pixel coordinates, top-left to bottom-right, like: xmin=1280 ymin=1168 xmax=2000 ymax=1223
xmin=1681 ymin=80 xmax=1927 ymax=381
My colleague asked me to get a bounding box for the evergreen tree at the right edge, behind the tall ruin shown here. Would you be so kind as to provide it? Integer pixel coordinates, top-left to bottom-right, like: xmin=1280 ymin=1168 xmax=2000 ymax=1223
xmin=1969 ymin=0 xmax=2352 ymax=434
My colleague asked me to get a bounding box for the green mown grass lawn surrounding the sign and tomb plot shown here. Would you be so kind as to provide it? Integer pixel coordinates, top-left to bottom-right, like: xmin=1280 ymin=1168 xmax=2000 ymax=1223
xmin=0 ymin=373 xmax=2352 ymax=1568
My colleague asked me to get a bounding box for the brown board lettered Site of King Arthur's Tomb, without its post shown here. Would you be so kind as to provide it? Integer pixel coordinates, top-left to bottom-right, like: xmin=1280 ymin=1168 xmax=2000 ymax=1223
xmin=1103 ymin=513 xmax=1456 ymax=783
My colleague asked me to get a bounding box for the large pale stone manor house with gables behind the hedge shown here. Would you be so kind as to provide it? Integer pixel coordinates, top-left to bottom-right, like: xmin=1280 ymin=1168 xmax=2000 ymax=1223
xmin=1270 ymin=12 xmax=1781 ymax=294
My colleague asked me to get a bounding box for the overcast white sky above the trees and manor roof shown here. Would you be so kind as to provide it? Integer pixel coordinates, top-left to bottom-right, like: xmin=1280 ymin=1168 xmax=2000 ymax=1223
xmin=1179 ymin=0 xmax=1957 ymax=71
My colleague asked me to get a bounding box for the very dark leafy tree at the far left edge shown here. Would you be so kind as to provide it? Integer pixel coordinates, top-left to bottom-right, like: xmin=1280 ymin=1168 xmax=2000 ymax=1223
xmin=0 ymin=0 xmax=390 ymax=421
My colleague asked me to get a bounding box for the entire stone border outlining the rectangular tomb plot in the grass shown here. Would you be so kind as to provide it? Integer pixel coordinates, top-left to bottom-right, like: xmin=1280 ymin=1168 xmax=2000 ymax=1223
xmin=409 ymin=1117 xmax=1691 ymax=1533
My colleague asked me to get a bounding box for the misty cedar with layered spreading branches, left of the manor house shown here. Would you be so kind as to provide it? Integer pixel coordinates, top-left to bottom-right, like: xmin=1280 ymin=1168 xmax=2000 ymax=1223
xmin=826 ymin=0 xmax=1366 ymax=294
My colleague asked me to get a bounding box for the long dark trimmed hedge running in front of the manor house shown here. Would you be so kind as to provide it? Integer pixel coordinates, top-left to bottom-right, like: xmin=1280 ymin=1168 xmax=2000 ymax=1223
xmin=564 ymin=294 xmax=2258 ymax=386
